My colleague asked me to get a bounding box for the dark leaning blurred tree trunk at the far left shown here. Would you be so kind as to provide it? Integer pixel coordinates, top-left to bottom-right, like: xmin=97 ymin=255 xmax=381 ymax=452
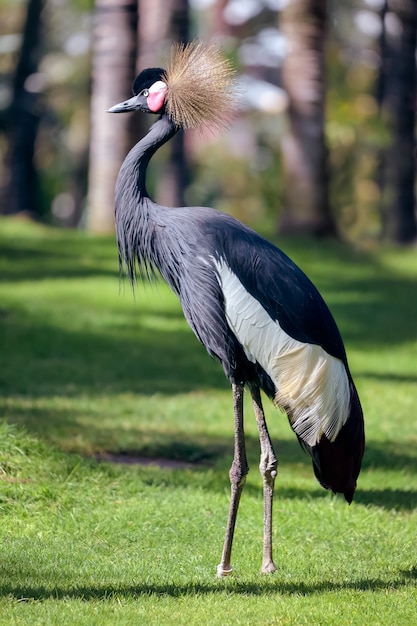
xmin=0 ymin=0 xmax=44 ymax=215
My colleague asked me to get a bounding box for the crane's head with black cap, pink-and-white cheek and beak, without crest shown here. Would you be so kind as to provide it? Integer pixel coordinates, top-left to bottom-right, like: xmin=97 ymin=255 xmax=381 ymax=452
xmin=108 ymin=67 xmax=168 ymax=113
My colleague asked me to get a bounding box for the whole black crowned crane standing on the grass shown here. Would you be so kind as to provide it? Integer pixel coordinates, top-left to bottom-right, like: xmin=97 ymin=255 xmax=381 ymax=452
xmin=110 ymin=42 xmax=364 ymax=577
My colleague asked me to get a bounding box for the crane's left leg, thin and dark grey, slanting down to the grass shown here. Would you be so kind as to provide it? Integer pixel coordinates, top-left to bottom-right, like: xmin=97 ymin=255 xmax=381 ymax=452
xmin=217 ymin=384 xmax=249 ymax=578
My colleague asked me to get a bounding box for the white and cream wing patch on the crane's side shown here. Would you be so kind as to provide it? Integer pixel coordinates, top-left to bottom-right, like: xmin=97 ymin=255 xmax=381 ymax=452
xmin=213 ymin=259 xmax=350 ymax=446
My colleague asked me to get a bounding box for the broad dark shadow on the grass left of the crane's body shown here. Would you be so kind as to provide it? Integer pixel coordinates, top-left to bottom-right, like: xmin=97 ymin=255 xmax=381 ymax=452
xmin=0 ymin=306 xmax=228 ymax=397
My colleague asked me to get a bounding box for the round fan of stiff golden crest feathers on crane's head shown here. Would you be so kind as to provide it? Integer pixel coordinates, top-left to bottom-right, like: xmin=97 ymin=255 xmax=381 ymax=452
xmin=163 ymin=41 xmax=236 ymax=130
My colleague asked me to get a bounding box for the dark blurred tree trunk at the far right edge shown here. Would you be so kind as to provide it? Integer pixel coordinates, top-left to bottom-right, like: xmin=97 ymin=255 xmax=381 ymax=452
xmin=379 ymin=0 xmax=417 ymax=244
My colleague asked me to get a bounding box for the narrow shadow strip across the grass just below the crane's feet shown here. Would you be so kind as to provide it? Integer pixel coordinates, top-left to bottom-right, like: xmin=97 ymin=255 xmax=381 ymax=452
xmin=0 ymin=566 xmax=417 ymax=602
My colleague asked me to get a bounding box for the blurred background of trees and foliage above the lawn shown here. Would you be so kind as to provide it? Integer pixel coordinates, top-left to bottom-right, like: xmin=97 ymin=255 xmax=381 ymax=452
xmin=0 ymin=0 xmax=417 ymax=244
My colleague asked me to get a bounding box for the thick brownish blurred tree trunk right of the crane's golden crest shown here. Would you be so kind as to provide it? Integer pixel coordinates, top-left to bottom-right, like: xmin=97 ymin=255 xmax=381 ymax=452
xmin=279 ymin=0 xmax=336 ymax=235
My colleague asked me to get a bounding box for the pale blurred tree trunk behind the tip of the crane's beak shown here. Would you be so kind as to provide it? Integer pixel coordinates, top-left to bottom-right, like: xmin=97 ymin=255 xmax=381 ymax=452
xmin=87 ymin=0 xmax=138 ymax=233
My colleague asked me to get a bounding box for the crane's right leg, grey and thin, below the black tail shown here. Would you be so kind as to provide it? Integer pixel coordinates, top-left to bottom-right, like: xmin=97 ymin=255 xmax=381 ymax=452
xmin=249 ymin=384 xmax=278 ymax=574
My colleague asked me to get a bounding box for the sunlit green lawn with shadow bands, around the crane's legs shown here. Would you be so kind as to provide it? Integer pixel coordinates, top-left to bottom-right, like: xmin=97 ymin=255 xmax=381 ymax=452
xmin=0 ymin=213 xmax=417 ymax=626
